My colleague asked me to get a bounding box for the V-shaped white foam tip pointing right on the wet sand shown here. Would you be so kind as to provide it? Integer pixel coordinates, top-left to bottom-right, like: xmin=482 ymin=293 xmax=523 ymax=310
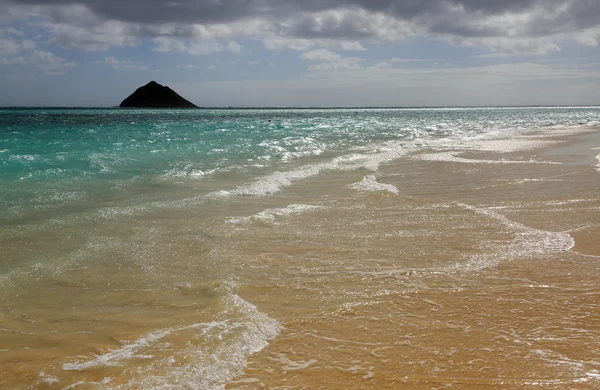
xmin=458 ymin=203 xmax=575 ymax=268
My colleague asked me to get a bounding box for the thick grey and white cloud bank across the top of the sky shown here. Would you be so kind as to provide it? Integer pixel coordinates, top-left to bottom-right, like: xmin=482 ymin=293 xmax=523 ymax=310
xmin=0 ymin=0 xmax=600 ymax=55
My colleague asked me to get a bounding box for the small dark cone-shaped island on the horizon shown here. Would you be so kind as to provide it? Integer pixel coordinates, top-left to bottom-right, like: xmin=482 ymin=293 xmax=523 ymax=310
xmin=119 ymin=81 xmax=198 ymax=108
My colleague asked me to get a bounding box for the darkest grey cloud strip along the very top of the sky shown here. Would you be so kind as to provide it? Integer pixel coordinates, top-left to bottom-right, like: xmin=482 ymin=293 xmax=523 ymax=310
xmin=4 ymin=0 xmax=540 ymax=23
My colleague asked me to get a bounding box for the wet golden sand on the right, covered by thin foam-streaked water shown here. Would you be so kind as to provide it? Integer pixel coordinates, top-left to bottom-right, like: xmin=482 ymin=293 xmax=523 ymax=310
xmin=227 ymin=129 xmax=600 ymax=389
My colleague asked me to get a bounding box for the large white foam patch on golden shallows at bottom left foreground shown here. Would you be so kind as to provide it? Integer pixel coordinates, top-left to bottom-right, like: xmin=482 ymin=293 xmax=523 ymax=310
xmin=63 ymin=294 xmax=279 ymax=389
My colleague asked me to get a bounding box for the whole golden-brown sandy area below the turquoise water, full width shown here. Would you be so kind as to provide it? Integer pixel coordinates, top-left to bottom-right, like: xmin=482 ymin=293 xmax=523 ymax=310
xmin=0 ymin=127 xmax=600 ymax=389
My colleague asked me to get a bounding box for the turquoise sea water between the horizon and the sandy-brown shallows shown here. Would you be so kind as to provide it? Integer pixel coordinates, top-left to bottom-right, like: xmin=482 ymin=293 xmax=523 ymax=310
xmin=0 ymin=107 xmax=600 ymax=223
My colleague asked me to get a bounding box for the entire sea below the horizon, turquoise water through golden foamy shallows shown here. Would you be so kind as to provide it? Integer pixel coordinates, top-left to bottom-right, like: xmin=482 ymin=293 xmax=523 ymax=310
xmin=0 ymin=107 xmax=600 ymax=389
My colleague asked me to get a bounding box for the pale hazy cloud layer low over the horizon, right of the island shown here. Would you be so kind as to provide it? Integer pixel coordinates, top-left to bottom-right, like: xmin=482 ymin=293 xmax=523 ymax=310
xmin=172 ymin=62 xmax=600 ymax=106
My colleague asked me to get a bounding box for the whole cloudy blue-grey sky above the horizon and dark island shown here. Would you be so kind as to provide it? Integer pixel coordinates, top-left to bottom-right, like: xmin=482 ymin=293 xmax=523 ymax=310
xmin=0 ymin=0 xmax=600 ymax=107
